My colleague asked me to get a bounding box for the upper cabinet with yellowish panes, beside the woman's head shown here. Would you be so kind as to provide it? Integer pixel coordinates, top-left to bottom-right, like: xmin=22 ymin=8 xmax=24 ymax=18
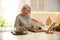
xmin=30 ymin=0 xmax=44 ymax=12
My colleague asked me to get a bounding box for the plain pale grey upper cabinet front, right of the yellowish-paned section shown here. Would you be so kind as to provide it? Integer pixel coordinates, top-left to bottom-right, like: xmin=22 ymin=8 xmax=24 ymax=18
xmin=44 ymin=0 xmax=58 ymax=12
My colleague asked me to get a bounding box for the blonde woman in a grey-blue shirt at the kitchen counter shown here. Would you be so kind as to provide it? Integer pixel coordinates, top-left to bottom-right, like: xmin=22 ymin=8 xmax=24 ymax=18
xmin=14 ymin=4 xmax=41 ymax=34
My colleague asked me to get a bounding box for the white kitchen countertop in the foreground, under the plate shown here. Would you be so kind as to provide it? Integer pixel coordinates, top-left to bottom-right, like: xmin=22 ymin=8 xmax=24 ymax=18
xmin=0 ymin=32 xmax=60 ymax=40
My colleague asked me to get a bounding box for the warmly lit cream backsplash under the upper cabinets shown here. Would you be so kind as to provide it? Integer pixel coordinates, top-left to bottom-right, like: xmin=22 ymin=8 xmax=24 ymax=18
xmin=31 ymin=12 xmax=60 ymax=24
